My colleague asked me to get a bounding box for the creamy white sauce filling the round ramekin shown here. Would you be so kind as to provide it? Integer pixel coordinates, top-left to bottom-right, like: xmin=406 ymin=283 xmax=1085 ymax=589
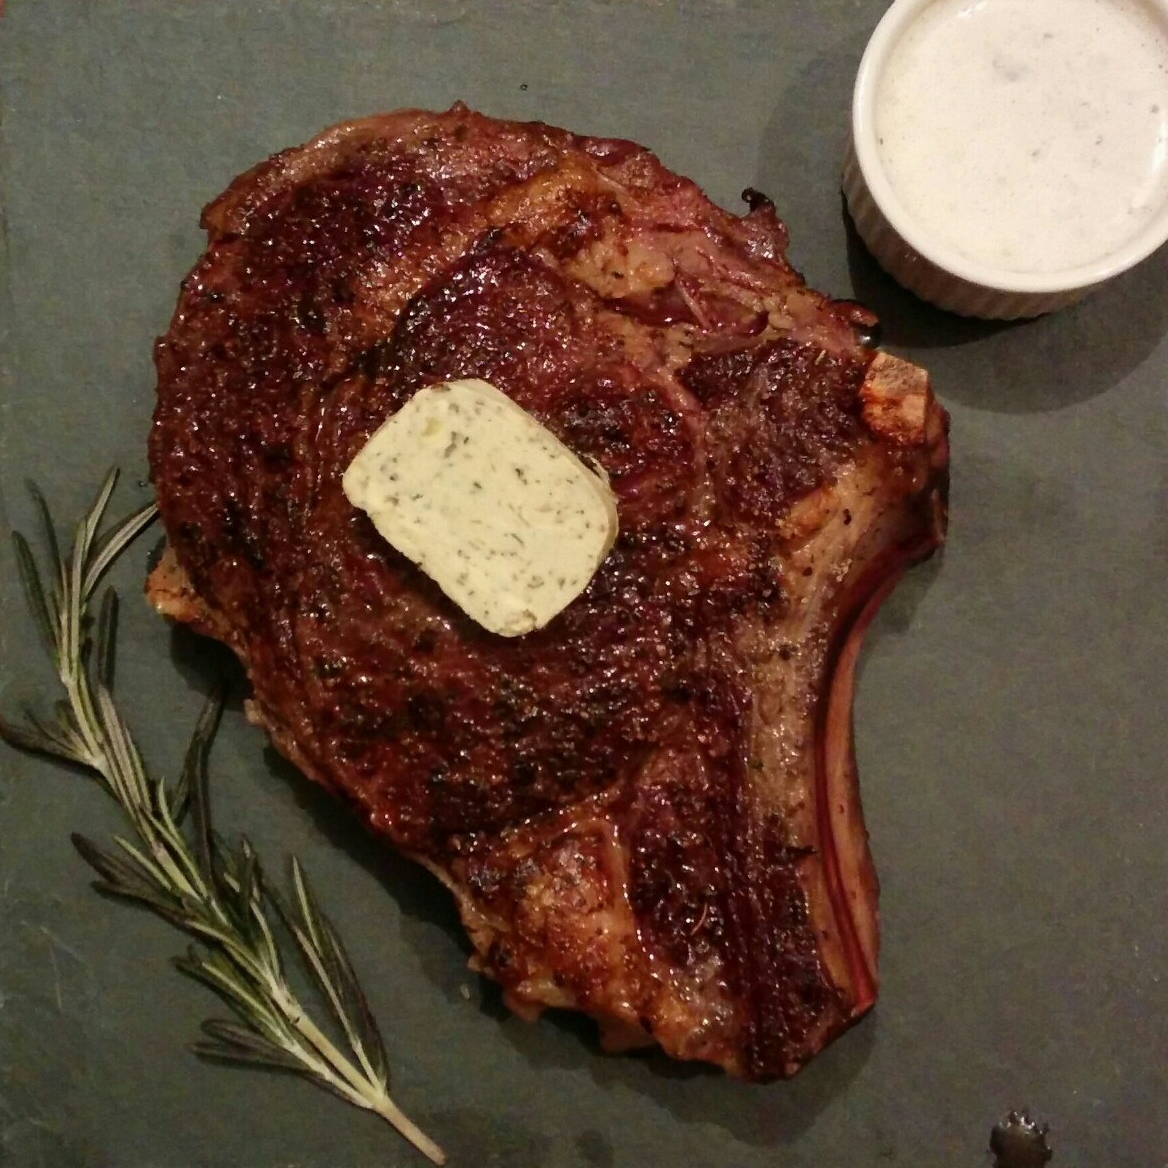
xmin=875 ymin=0 xmax=1168 ymax=272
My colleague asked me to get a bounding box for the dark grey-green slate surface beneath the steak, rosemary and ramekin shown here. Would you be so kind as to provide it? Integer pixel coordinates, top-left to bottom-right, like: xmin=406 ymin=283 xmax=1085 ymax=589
xmin=0 ymin=0 xmax=1168 ymax=1168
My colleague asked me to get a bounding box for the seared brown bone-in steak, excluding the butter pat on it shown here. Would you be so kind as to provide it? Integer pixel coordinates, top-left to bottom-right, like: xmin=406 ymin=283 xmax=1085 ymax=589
xmin=147 ymin=105 xmax=947 ymax=1079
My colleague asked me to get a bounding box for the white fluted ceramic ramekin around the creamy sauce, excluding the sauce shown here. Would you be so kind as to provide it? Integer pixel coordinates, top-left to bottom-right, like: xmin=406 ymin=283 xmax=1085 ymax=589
xmin=843 ymin=0 xmax=1168 ymax=320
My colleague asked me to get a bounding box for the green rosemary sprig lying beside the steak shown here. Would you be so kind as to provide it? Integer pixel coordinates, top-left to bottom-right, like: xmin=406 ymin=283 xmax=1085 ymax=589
xmin=0 ymin=471 xmax=446 ymax=1164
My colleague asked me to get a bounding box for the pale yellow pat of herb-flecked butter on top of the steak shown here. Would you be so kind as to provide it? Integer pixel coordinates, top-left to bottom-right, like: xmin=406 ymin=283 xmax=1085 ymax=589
xmin=342 ymin=380 xmax=617 ymax=637
